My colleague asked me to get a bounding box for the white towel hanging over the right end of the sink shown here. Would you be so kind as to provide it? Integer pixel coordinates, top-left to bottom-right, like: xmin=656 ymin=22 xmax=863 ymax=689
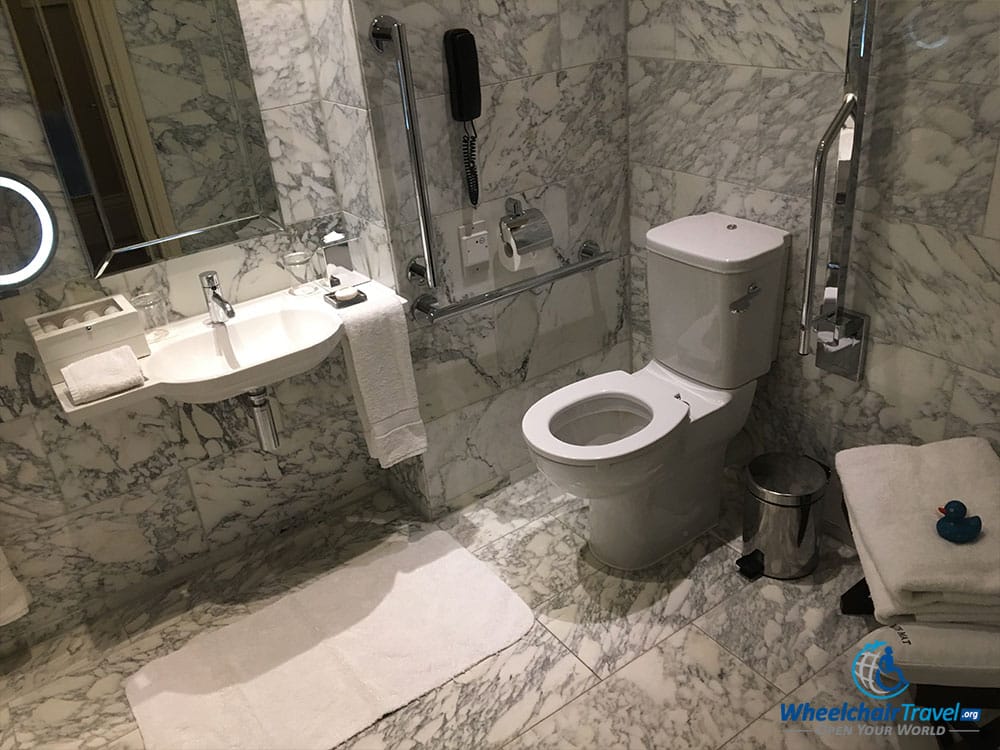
xmin=339 ymin=283 xmax=427 ymax=468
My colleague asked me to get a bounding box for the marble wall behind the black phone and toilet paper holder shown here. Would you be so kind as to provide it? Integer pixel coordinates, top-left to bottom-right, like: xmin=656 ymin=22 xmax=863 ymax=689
xmin=350 ymin=0 xmax=628 ymax=516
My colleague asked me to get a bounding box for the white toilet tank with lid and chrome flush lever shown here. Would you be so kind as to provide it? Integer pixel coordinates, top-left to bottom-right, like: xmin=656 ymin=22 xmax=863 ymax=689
xmin=646 ymin=213 xmax=790 ymax=388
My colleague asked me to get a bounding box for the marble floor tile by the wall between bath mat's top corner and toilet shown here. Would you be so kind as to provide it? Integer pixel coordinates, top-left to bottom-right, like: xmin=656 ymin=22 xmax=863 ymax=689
xmin=437 ymin=472 xmax=569 ymax=550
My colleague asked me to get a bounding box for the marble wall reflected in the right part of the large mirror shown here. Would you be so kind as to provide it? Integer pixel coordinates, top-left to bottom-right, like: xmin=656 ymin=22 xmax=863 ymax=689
xmin=114 ymin=0 xmax=278 ymax=242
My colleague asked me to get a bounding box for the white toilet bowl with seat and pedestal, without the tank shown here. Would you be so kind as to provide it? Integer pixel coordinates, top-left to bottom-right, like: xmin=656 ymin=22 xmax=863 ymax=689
xmin=521 ymin=362 xmax=755 ymax=570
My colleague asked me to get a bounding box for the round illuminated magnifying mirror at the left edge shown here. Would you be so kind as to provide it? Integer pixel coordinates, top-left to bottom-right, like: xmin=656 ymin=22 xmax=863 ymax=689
xmin=0 ymin=172 xmax=56 ymax=291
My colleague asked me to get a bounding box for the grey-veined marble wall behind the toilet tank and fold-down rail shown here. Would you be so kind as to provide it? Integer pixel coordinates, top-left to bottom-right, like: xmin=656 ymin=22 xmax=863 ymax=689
xmin=627 ymin=0 xmax=1000 ymax=528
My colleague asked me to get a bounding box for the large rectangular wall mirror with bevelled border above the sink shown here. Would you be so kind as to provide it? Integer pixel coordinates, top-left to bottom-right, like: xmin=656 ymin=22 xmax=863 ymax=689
xmin=2 ymin=0 xmax=281 ymax=276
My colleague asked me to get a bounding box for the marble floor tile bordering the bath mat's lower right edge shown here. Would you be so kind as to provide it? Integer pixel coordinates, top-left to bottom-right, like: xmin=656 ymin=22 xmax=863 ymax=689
xmin=339 ymin=623 xmax=597 ymax=750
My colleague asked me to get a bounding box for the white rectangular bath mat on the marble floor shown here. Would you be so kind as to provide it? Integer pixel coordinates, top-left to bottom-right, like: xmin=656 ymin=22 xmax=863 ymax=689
xmin=126 ymin=531 xmax=532 ymax=750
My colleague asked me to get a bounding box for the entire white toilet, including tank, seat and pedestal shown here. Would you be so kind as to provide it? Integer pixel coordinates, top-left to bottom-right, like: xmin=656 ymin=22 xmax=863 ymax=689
xmin=521 ymin=213 xmax=790 ymax=570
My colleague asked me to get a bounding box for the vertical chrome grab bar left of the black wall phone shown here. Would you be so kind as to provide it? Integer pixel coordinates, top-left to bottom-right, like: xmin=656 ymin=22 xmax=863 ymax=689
xmin=371 ymin=15 xmax=437 ymax=288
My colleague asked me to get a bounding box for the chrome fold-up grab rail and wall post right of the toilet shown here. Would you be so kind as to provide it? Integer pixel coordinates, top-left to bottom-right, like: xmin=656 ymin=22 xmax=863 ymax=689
xmin=799 ymin=0 xmax=877 ymax=380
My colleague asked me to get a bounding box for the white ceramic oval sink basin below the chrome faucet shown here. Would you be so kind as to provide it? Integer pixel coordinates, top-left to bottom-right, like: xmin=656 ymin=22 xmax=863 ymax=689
xmin=141 ymin=292 xmax=341 ymax=404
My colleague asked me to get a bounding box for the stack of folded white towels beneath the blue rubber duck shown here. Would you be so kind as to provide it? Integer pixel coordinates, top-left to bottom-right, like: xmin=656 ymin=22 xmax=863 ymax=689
xmin=836 ymin=438 xmax=1000 ymax=625
